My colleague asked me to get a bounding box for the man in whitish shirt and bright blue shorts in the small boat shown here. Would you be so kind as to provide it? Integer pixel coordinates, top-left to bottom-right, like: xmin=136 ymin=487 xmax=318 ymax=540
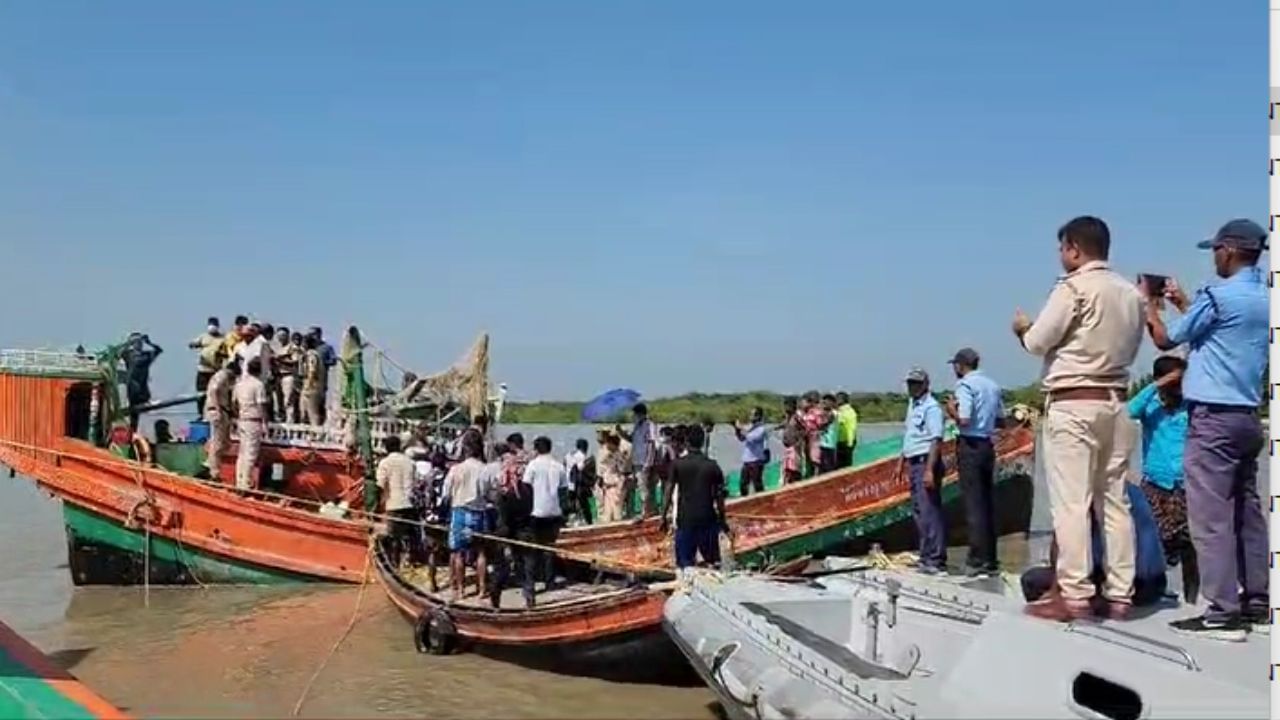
xmin=444 ymin=442 xmax=489 ymax=598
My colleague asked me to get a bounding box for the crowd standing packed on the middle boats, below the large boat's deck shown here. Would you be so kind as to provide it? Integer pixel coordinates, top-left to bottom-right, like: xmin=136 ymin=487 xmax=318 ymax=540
xmin=376 ymin=393 xmax=875 ymax=607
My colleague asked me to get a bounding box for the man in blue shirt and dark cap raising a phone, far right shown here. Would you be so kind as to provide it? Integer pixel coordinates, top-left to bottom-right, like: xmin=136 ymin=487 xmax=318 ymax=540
xmin=1147 ymin=220 xmax=1271 ymax=642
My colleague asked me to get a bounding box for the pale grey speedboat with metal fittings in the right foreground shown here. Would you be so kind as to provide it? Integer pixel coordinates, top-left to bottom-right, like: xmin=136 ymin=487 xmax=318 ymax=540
xmin=664 ymin=559 xmax=1270 ymax=720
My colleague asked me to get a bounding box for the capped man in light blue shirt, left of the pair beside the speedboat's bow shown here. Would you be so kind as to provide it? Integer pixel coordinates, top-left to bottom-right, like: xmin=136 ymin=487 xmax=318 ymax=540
xmin=893 ymin=368 xmax=947 ymax=575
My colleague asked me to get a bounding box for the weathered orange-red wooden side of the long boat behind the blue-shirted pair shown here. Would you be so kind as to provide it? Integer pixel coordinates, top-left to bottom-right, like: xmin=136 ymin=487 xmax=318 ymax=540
xmin=557 ymin=424 xmax=1036 ymax=569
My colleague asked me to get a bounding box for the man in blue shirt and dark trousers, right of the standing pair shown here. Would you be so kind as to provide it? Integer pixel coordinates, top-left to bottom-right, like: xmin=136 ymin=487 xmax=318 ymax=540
xmin=946 ymin=347 xmax=1005 ymax=577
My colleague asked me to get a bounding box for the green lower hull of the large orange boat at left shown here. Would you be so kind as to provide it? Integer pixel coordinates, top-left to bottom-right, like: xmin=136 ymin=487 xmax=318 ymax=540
xmin=63 ymin=502 xmax=324 ymax=585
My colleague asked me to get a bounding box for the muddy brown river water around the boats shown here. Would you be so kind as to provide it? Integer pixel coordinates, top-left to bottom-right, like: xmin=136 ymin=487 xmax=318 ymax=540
xmin=0 ymin=425 xmax=1266 ymax=719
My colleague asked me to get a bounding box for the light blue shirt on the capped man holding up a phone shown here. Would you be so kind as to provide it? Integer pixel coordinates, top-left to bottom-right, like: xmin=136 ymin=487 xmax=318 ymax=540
xmin=1169 ymin=268 xmax=1271 ymax=407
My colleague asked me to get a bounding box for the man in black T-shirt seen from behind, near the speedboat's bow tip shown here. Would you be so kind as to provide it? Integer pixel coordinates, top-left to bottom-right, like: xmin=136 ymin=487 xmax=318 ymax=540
xmin=662 ymin=425 xmax=730 ymax=568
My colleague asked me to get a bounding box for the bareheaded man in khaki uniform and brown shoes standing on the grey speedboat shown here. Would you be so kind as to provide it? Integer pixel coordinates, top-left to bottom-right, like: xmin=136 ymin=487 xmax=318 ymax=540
xmin=1014 ymin=217 xmax=1144 ymax=620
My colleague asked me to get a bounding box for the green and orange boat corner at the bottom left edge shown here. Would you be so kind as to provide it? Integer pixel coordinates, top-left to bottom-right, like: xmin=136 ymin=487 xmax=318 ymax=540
xmin=0 ymin=623 xmax=128 ymax=720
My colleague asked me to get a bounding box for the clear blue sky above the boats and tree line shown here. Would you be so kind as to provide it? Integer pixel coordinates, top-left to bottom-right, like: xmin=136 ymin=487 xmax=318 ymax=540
xmin=0 ymin=0 xmax=1267 ymax=398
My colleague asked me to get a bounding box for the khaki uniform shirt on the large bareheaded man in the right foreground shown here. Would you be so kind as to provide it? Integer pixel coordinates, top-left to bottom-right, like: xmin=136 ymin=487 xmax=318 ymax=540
xmin=1023 ymin=261 xmax=1146 ymax=392
